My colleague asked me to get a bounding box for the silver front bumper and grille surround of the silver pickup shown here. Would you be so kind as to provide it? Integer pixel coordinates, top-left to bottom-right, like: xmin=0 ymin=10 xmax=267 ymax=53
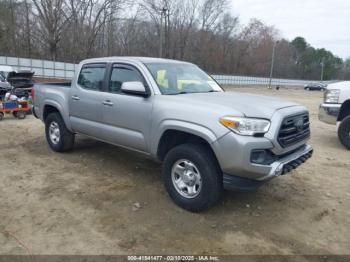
xmin=211 ymin=106 xmax=313 ymax=189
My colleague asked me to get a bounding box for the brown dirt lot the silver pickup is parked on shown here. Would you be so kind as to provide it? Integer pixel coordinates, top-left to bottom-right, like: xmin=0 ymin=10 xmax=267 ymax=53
xmin=0 ymin=88 xmax=350 ymax=254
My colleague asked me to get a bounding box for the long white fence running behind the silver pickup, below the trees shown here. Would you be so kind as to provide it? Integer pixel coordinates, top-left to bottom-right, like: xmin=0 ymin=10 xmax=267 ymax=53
xmin=0 ymin=56 xmax=328 ymax=86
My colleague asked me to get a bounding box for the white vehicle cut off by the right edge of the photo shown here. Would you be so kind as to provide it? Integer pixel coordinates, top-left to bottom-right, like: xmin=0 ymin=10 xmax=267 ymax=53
xmin=319 ymin=81 xmax=350 ymax=150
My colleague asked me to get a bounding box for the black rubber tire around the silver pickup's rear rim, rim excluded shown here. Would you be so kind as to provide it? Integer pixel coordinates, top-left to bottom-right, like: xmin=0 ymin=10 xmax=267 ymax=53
xmin=45 ymin=113 xmax=75 ymax=152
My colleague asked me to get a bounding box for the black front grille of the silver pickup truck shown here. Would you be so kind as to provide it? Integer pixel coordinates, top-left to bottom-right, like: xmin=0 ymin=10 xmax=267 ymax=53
xmin=278 ymin=113 xmax=310 ymax=148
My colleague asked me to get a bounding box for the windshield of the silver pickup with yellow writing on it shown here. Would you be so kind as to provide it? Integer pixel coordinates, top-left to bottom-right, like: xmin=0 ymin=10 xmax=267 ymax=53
xmin=145 ymin=63 xmax=223 ymax=95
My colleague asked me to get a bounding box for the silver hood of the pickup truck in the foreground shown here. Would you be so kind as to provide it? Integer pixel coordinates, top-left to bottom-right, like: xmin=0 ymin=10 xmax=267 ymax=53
xmin=166 ymin=92 xmax=298 ymax=119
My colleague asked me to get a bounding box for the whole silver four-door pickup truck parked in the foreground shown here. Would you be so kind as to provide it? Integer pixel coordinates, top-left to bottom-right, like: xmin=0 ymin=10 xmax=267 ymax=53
xmin=33 ymin=57 xmax=313 ymax=211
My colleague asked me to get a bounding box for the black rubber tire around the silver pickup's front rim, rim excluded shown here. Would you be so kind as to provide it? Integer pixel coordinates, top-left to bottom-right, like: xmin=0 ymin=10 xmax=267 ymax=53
xmin=162 ymin=144 xmax=223 ymax=212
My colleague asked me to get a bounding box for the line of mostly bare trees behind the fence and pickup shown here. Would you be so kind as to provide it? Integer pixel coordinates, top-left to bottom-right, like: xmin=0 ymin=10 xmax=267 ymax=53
xmin=0 ymin=0 xmax=350 ymax=80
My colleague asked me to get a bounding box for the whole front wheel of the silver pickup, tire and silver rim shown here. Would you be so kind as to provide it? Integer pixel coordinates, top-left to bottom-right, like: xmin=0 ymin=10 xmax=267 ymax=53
xmin=162 ymin=144 xmax=222 ymax=212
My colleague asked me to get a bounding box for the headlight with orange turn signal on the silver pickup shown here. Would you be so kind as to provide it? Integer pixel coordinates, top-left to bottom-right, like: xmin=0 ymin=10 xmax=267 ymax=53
xmin=220 ymin=116 xmax=270 ymax=136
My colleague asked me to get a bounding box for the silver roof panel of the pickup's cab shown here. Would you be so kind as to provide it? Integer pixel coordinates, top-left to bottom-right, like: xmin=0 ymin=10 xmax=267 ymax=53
xmin=81 ymin=56 xmax=188 ymax=63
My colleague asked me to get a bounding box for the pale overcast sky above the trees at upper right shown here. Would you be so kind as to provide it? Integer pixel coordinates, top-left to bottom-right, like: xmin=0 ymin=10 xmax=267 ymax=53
xmin=229 ymin=0 xmax=350 ymax=59
